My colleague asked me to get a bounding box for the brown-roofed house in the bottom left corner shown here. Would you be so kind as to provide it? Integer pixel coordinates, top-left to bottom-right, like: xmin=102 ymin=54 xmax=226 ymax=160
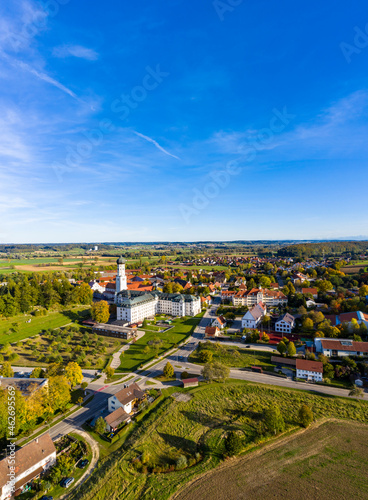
xmin=0 ymin=434 xmax=56 ymax=500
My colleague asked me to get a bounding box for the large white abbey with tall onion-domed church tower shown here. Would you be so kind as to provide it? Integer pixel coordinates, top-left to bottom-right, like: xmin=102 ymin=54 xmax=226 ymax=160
xmin=115 ymin=257 xmax=201 ymax=323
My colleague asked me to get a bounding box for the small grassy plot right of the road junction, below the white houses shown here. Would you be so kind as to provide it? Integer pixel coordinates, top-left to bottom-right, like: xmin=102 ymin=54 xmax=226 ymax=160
xmin=189 ymin=342 xmax=274 ymax=371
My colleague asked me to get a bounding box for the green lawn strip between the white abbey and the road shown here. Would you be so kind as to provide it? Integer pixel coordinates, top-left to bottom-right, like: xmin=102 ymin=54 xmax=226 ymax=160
xmin=118 ymin=313 xmax=204 ymax=372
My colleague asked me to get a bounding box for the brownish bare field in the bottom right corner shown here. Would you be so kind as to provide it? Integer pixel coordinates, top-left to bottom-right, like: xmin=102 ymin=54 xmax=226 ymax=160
xmin=173 ymin=422 xmax=368 ymax=500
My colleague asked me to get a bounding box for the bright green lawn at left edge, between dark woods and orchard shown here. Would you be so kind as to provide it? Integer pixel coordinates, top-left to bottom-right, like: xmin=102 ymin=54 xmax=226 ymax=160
xmin=0 ymin=306 xmax=90 ymax=344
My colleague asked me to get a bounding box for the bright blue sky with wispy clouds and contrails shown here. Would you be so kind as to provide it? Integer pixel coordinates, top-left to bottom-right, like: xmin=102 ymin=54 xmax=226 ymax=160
xmin=0 ymin=0 xmax=368 ymax=243
